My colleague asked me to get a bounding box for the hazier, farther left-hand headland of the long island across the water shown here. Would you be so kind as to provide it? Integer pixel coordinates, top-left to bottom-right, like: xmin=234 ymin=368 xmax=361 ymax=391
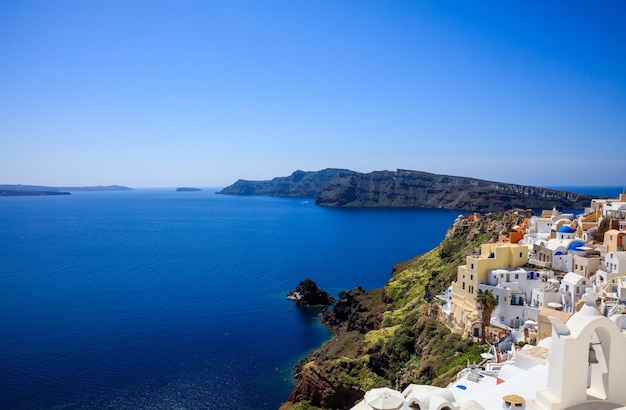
xmin=218 ymin=168 xmax=354 ymax=198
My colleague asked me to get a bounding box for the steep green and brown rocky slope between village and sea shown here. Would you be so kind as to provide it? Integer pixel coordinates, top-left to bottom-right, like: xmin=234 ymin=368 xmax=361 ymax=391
xmin=281 ymin=210 xmax=533 ymax=410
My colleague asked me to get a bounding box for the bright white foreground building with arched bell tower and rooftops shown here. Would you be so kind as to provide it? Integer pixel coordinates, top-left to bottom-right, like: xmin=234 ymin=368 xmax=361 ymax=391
xmin=352 ymin=294 xmax=626 ymax=410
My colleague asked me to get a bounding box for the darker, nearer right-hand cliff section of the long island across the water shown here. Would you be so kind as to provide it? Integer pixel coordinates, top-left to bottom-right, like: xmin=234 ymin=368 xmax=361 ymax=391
xmin=316 ymin=170 xmax=592 ymax=212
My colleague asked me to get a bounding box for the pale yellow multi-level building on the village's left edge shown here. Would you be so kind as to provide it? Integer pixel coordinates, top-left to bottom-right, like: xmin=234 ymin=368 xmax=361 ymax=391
xmin=450 ymin=242 xmax=529 ymax=337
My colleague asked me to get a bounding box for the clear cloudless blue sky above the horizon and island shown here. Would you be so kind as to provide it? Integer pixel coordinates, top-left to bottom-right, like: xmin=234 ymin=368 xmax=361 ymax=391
xmin=0 ymin=0 xmax=626 ymax=187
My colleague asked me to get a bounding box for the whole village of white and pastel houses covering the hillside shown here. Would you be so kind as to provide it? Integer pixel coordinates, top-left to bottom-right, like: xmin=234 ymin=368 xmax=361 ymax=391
xmin=353 ymin=193 xmax=626 ymax=410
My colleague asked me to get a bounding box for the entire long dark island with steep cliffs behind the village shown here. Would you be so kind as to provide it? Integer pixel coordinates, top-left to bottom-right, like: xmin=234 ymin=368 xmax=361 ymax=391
xmin=218 ymin=168 xmax=593 ymax=212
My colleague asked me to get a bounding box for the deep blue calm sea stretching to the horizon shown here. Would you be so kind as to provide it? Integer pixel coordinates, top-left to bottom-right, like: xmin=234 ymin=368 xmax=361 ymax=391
xmin=0 ymin=187 xmax=622 ymax=409
